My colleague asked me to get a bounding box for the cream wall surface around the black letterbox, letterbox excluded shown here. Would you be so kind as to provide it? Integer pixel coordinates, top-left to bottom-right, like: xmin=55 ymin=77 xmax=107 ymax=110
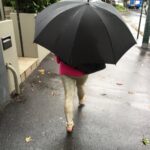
xmin=0 ymin=20 xmax=20 ymax=93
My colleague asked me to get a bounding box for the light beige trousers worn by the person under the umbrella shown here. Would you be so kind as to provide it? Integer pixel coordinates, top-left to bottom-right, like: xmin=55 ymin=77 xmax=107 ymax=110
xmin=62 ymin=75 xmax=88 ymax=124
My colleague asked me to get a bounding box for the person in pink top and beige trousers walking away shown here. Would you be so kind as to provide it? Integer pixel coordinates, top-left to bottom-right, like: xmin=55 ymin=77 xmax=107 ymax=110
xmin=56 ymin=56 xmax=88 ymax=133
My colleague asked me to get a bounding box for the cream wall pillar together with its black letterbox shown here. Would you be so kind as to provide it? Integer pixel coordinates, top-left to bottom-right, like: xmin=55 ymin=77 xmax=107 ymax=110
xmin=0 ymin=20 xmax=21 ymax=94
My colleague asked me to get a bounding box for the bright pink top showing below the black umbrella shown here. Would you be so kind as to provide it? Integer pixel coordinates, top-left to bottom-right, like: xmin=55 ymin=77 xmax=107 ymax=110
xmin=56 ymin=57 xmax=84 ymax=77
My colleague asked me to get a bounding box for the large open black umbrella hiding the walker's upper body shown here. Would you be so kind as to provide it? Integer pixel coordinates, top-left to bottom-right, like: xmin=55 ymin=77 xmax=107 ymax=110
xmin=35 ymin=1 xmax=136 ymax=73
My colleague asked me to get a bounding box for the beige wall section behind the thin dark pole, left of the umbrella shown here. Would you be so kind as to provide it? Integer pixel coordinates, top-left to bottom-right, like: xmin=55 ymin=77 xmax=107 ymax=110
xmin=10 ymin=13 xmax=38 ymax=58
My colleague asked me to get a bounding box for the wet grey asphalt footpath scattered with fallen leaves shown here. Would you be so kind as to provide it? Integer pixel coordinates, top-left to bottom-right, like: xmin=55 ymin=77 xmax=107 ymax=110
xmin=0 ymin=20 xmax=150 ymax=150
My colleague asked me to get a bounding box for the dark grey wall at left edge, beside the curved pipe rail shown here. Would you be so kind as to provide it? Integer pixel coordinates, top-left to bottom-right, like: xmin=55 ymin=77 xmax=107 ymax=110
xmin=0 ymin=41 xmax=10 ymax=109
